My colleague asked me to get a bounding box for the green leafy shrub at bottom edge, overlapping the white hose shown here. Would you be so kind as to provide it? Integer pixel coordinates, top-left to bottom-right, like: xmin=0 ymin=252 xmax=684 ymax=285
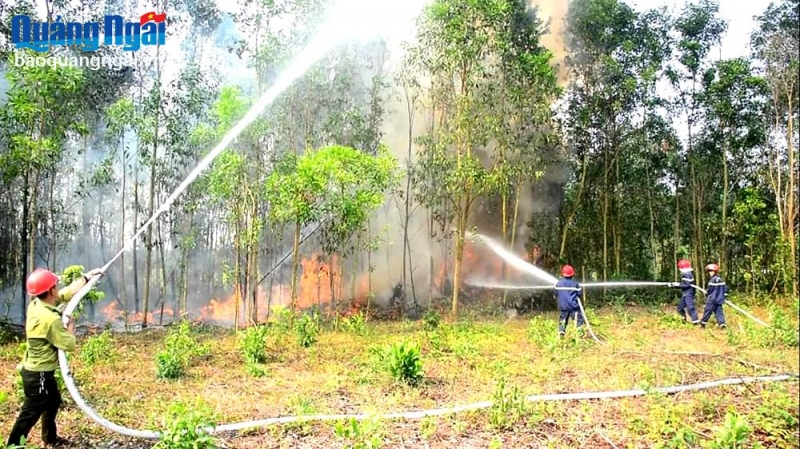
xmin=154 ymin=401 xmax=219 ymax=449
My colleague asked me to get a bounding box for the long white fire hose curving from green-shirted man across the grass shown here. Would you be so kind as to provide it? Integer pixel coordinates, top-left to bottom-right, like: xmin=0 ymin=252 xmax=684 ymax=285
xmin=58 ymin=276 xmax=798 ymax=440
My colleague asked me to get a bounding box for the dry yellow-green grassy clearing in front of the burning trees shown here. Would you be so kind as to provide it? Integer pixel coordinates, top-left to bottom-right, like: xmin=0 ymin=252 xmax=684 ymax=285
xmin=0 ymin=300 xmax=800 ymax=449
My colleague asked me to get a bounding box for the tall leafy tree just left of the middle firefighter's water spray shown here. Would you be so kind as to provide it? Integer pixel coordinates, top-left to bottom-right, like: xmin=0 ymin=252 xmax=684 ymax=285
xmin=410 ymin=0 xmax=520 ymax=315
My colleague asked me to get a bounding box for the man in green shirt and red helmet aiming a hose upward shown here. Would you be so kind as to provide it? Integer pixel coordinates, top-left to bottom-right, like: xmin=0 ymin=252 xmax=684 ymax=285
xmin=6 ymin=268 xmax=102 ymax=447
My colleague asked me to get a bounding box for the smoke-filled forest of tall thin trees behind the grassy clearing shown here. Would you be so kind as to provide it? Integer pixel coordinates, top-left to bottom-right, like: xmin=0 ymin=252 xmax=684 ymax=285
xmin=0 ymin=0 xmax=800 ymax=323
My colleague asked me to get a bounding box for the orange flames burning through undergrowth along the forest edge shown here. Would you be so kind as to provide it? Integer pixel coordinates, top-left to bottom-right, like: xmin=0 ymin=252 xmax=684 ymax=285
xmin=94 ymin=240 xmax=544 ymax=328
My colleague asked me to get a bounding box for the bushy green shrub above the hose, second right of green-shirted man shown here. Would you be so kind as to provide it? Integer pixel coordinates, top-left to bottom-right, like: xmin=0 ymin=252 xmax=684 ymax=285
xmin=156 ymin=320 xmax=210 ymax=379
